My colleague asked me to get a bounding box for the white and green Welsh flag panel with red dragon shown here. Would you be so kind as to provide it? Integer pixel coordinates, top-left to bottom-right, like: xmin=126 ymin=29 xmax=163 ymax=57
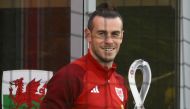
xmin=1 ymin=70 xmax=53 ymax=109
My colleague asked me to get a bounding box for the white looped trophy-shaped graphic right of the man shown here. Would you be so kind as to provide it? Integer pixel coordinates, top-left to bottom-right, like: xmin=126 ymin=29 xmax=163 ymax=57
xmin=128 ymin=59 xmax=151 ymax=109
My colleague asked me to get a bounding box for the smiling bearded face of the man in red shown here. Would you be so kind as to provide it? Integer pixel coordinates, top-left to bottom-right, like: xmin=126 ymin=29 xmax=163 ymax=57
xmin=86 ymin=16 xmax=123 ymax=64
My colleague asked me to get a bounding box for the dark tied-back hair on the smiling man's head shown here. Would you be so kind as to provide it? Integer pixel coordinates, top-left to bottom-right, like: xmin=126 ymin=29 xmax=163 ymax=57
xmin=87 ymin=3 xmax=123 ymax=30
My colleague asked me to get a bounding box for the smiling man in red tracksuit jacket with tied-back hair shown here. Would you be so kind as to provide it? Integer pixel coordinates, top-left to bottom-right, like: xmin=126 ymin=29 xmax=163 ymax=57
xmin=41 ymin=4 xmax=128 ymax=109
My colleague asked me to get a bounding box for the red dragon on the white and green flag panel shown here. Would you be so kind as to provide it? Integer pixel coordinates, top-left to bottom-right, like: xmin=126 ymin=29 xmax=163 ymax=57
xmin=9 ymin=77 xmax=47 ymax=109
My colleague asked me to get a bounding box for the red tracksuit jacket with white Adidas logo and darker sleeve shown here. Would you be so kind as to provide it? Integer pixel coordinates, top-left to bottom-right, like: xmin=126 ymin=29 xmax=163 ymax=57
xmin=40 ymin=53 xmax=128 ymax=109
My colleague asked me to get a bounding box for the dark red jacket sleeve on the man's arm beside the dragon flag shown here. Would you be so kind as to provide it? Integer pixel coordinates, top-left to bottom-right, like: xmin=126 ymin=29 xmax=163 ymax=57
xmin=40 ymin=65 xmax=84 ymax=109
